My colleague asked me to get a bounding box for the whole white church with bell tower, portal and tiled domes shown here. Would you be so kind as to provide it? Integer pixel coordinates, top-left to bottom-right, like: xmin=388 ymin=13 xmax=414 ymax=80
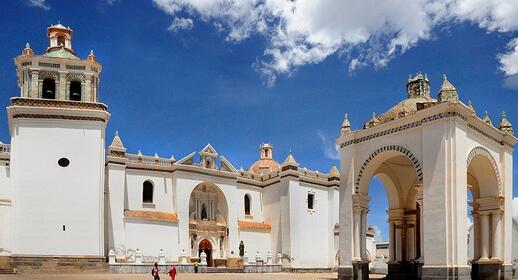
xmin=0 ymin=24 xmax=340 ymax=268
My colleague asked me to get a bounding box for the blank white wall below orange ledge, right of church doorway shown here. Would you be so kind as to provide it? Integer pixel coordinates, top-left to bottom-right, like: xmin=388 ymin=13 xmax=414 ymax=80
xmin=240 ymin=230 xmax=275 ymax=262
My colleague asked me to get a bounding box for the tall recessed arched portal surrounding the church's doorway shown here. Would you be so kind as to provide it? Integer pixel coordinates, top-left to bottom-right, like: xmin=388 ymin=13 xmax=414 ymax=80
xmin=189 ymin=182 xmax=229 ymax=265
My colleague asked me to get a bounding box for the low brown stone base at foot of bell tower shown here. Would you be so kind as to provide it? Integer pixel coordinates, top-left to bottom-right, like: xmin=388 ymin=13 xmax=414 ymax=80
xmin=10 ymin=255 xmax=108 ymax=273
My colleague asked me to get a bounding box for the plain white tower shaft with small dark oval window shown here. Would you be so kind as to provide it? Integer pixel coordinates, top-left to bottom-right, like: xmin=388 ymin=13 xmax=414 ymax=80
xmin=11 ymin=119 xmax=105 ymax=256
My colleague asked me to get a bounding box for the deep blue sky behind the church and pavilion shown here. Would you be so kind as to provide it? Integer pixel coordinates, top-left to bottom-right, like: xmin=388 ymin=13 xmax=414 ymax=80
xmin=0 ymin=0 xmax=518 ymax=241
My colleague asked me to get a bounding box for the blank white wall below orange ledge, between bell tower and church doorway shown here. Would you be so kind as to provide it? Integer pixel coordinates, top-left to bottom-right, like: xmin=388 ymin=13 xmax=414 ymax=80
xmin=124 ymin=219 xmax=182 ymax=261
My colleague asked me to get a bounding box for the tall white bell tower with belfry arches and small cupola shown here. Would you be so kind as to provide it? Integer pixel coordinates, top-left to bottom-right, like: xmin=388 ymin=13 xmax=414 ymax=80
xmin=7 ymin=24 xmax=110 ymax=257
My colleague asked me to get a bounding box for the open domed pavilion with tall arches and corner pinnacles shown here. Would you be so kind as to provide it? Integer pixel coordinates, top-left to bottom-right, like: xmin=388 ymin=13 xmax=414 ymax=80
xmin=337 ymin=74 xmax=518 ymax=279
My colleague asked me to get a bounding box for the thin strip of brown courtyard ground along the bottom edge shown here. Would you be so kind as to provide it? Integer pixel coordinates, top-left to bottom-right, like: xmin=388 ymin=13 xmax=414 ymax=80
xmin=0 ymin=273 xmax=388 ymax=280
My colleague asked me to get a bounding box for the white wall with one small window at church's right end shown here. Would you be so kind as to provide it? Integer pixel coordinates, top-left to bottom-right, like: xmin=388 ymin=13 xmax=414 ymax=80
xmin=289 ymin=181 xmax=334 ymax=268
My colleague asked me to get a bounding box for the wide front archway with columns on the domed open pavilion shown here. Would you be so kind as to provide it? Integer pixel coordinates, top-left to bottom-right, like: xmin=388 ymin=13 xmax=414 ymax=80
xmin=353 ymin=145 xmax=422 ymax=278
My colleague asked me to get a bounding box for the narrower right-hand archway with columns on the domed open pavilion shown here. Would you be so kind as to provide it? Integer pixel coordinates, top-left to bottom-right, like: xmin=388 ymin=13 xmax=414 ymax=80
xmin=466 ymin=147 xmax=504 ymax=279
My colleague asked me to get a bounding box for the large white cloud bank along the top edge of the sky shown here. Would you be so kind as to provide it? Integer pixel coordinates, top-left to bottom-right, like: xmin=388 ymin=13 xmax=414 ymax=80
xmin=153 ymin=0 xmax=518 ymax=84
